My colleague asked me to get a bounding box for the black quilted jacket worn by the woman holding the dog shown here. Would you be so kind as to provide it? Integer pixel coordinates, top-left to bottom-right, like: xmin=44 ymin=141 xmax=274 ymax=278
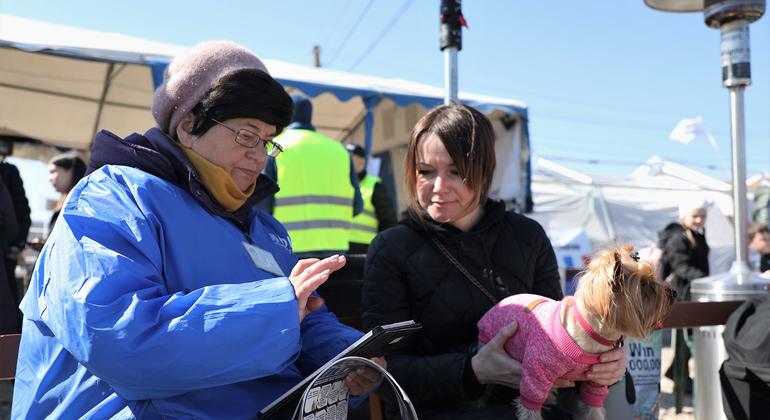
xmin=363 ymin=200 xmax=562 ymax=414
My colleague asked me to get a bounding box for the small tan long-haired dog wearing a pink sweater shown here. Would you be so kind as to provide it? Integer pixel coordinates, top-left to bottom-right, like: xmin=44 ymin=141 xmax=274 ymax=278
xmin=478 ymin=245 xmax=676 ymax=419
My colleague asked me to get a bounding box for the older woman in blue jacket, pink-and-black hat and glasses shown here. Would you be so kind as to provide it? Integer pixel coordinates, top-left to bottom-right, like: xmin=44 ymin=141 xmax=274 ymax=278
xmin=12 ymin=42 xmax=379 ymax=418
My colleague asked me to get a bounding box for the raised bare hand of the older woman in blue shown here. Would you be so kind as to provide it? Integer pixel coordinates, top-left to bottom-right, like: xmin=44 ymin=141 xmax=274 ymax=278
xmin=289 ymin=255 xmax=346 ymax=322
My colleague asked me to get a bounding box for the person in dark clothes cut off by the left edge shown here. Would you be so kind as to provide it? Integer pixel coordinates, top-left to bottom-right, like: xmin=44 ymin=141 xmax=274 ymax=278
xmin=0 ymin=144 xmax=32 ymax=332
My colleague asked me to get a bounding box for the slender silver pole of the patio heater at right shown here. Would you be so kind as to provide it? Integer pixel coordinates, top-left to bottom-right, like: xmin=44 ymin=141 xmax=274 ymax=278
xmin=729 ymin=86 xmax=748 ymax=272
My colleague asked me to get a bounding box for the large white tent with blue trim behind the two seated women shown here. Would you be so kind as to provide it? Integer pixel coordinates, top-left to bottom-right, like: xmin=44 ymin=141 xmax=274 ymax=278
xmin=0 ymin=14 xmax=529 ymax=209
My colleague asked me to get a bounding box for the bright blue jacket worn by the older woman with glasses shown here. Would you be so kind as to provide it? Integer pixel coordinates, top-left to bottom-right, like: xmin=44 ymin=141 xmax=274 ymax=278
xmin=12 ymin=130 xmax=361 ymax=419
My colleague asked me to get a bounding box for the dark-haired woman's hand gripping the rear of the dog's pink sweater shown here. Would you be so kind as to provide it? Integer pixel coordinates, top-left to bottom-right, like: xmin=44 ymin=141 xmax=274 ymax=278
xmin=471 ymin=322 xmax=521 ymax=388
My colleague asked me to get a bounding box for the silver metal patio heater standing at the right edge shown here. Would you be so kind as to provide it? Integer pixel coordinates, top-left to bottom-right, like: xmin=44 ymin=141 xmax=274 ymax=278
xmin=644 ymin=0 xmax=770 ymax=419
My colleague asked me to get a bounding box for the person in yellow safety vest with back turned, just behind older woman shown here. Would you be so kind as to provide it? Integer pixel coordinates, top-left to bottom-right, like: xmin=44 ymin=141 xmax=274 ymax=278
xmin=259 ymin=94 xmax=363 ymax=258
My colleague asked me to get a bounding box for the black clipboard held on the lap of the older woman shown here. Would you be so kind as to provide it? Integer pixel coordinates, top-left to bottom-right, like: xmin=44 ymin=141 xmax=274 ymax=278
xmin=258 ymin=320 xmax=422 ymax=419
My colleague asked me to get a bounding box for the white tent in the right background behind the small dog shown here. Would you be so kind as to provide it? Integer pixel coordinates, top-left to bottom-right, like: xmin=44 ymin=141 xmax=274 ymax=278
xmin=529 ymin=157 xmax=733 ymax=273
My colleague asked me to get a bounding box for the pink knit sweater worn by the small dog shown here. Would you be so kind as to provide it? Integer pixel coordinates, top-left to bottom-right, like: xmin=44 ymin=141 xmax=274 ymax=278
xmin=478 ymin=294 xmax=608 ymax=410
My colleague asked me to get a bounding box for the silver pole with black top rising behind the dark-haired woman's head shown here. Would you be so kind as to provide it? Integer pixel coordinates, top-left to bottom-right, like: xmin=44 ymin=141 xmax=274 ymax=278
xmin=439 ymin=0 xmax=468 ymax=104
